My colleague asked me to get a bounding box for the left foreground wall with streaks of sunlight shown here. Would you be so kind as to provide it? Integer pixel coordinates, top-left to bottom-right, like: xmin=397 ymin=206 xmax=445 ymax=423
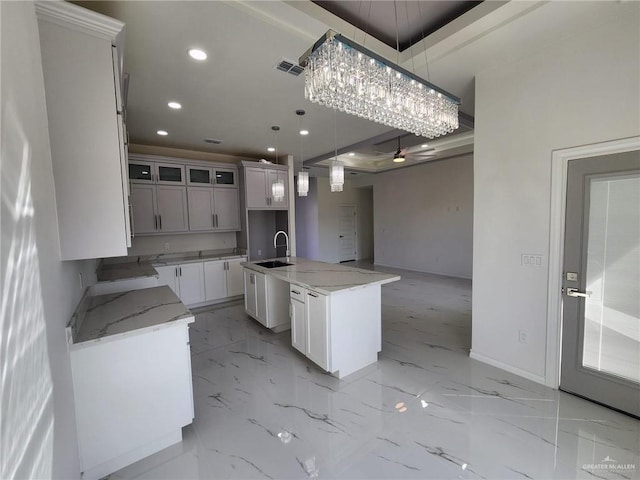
xmin=0 ymin=2 xmax=95 ymax=479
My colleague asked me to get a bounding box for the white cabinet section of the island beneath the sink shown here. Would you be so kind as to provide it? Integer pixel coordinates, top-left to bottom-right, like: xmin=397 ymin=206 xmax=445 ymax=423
xmin=244 ymin=268 xmax=291 ymax=332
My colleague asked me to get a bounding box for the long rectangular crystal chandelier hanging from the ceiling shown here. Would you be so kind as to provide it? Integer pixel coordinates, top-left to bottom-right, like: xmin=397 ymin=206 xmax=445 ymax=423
xmin=300 ymin=30 xmax=460 ymax=138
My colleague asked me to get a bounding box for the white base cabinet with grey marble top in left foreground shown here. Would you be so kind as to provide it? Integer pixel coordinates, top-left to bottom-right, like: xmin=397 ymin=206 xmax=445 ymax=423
xmin=67 ymin=286 xmax=194 ymax=479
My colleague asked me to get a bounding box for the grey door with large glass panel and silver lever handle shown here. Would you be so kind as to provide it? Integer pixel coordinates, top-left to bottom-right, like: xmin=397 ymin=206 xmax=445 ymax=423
xmin=560 ymin=151 xmax=640 ymax=416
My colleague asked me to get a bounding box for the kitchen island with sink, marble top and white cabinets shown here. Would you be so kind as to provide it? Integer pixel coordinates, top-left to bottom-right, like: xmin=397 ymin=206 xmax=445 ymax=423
xmin=242 ymin=257 xmax=400 ymax=378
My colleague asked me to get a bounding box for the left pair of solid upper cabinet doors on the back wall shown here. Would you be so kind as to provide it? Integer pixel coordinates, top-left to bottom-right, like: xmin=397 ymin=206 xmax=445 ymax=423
xmin=131 ymin=183 xmax=188 ymax=235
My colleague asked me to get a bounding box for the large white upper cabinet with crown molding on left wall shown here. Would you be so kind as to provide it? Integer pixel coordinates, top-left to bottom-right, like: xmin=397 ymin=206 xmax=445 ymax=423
xmin=36 ymin=2 xmax=131 ymax=260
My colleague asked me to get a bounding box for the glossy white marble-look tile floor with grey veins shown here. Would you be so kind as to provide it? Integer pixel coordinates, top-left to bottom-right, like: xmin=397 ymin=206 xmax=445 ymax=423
xmin=111 ymin=268 xmax=640 ymax=479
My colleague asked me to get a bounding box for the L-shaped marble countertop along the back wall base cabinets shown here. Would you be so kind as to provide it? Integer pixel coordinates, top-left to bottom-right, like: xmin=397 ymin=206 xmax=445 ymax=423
xmin=96 ymin=250 xmax=246 ymax=282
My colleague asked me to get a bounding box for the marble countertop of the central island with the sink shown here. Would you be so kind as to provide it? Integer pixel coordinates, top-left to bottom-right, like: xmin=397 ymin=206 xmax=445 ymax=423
xmin=242 ymin=257 xmax=400 ymax=295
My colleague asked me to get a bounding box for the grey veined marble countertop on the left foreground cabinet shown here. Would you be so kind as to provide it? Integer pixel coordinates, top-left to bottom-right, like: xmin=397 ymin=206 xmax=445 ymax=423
xmin=70 ymin=286 xmax=193 ymax=345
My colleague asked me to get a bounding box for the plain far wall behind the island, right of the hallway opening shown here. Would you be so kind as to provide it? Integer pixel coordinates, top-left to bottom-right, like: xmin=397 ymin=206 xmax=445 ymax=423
xmin=373 ymin=155 xmax=473 ymax=278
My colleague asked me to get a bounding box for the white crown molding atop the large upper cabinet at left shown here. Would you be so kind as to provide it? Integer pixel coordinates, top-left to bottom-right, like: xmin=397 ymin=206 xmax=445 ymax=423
xmin=35 ymin=0 xmax=124 ymax=42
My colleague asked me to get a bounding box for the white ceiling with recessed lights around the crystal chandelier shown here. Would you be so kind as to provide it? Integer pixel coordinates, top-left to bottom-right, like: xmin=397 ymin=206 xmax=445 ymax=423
xmin=77 ymin=0 xmax=620 ymax=172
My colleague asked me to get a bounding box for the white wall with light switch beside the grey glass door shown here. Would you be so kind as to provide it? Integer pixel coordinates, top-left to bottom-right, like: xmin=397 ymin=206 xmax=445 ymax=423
xmin=472 ymin=2 xmax=640 ymax=382
